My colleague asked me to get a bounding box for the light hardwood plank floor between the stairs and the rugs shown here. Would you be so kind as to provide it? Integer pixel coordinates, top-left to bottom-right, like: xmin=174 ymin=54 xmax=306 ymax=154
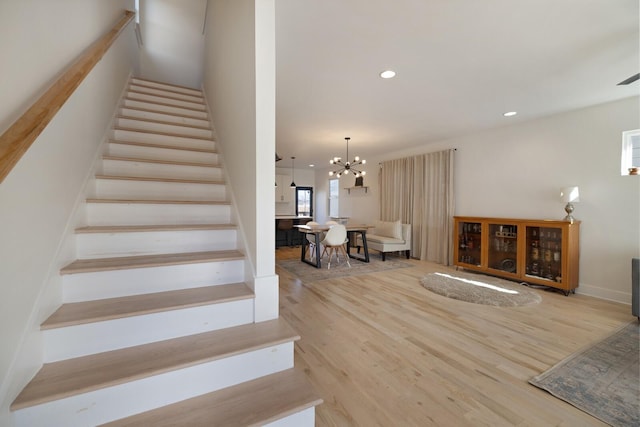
xmin=276 ymin=248 xmax=635 ymax=427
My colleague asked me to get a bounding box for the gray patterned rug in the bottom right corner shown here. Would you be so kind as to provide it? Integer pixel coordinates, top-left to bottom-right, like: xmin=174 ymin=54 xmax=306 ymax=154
xmin=529 ymin=320 xmax=640 ymax=426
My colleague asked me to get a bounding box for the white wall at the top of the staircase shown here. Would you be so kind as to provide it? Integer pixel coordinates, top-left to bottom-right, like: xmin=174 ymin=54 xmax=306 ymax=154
xmin=140 ymin=0 xmax=207 ymax=89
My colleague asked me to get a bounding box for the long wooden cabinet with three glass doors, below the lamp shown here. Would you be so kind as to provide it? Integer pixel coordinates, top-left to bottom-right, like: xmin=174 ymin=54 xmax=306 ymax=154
xmin=454 ymin=217 xmax=580 ymax=295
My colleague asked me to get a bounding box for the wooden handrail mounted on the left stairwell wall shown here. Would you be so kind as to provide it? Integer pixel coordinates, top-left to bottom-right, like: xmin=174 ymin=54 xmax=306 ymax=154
xmin=0 ymin=10 xmax=135 ymax=183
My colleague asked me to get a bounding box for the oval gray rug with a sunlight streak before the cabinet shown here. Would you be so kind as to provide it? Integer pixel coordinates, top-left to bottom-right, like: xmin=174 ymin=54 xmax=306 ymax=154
xmin=420 ymin=271 xmax=542 ymax=307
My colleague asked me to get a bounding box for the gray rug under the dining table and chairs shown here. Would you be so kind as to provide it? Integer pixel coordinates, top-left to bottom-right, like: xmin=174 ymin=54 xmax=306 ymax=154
xmin=276 ymin=255 xmax=411 ymax=283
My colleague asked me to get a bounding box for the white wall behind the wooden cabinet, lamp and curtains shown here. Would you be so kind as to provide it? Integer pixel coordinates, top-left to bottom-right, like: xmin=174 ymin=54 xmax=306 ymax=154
xmin=324 ymin=97 xmax=640 ymax=303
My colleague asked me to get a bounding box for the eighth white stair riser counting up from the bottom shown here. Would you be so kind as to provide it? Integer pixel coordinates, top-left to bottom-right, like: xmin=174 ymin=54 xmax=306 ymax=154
xmin=102 ymin=159 xmax=224 ymax=180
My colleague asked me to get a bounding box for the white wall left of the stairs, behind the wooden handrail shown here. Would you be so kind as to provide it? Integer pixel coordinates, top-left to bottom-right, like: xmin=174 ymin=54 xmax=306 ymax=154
xmin=0 ymin=0 xmax=135 ymax=426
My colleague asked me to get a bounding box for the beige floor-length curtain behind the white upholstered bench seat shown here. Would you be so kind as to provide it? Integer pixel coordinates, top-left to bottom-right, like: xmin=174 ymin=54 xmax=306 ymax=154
xmin=379 ymin=150 xmax=454 ymax=265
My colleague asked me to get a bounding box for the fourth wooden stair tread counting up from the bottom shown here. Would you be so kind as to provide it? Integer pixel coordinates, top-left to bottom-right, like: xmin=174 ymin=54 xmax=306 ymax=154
xmin=60 ymin=250 xmax=244 ymax=275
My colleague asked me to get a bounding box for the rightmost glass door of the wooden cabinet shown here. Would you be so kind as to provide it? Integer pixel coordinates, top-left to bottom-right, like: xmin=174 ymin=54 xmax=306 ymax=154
xmin=526 ymin=226 xmax=562 ymax=282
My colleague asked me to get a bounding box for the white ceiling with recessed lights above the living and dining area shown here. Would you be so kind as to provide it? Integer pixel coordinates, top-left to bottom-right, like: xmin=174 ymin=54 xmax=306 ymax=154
xmin=276 ymin=0 xmax=640 ymax=168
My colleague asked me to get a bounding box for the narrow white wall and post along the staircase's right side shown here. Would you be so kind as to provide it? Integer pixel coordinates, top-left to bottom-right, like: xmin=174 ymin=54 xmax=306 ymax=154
xmin=204 ymin=0 xmax=278 ymax=320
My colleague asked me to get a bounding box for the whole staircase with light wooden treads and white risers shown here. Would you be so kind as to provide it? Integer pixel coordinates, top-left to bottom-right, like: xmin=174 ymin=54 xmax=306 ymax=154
xmin=11 ymin=78 xmax=321 ymax=427
